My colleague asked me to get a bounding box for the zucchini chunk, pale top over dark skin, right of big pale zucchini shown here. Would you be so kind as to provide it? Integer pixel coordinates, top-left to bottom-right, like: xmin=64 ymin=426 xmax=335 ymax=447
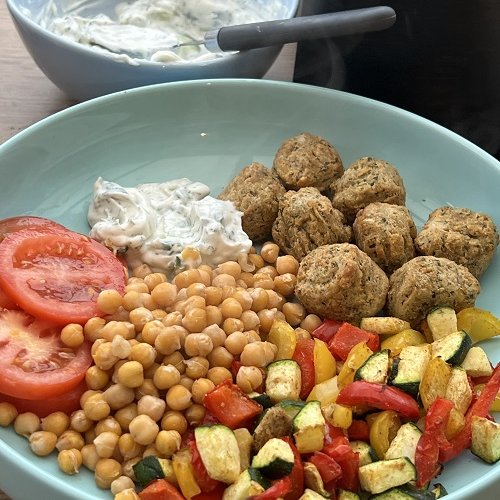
xmin=252 ymin=438 xmax=295 ymax=479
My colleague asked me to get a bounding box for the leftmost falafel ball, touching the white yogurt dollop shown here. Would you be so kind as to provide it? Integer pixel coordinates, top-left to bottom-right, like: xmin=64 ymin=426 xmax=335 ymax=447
xmin=218 ymin=162 xmax=285 ymax=242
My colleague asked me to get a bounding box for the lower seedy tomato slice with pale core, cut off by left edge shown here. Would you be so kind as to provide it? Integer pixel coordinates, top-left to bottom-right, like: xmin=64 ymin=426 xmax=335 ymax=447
xmin=0 ymin=309 xmax=92 ymax=399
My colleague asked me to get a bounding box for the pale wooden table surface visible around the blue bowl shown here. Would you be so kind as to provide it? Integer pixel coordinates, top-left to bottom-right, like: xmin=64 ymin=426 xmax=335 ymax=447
xmin=0 ymin=0 xmax=295 ymax=144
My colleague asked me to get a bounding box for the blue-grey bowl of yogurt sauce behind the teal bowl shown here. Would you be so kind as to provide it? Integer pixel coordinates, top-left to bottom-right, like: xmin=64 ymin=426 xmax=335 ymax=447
xmin=7 ymin=0 xmax=299 ymax=101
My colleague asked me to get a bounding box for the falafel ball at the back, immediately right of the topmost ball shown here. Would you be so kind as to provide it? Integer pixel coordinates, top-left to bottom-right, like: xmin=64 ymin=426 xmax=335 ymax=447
xmin=330 ymin=156 xmax=406 ymax=223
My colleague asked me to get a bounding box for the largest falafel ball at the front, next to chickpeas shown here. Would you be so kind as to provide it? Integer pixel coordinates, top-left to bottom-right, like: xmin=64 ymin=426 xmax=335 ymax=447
xmin=295 ymin=243 xmax=389 ymax=322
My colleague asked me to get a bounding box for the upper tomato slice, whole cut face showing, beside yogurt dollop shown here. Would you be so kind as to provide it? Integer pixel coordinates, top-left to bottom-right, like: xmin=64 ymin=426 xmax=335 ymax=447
xmin=0 ymin=229 xmax=125 ymax=325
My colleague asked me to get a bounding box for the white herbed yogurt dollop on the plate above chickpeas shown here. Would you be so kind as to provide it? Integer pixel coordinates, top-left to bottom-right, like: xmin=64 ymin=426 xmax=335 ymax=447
xmin=88 ymin=177 xmax=252 ymax=274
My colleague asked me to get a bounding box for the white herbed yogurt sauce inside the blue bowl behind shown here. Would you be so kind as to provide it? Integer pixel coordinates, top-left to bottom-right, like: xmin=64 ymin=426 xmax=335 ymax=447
xmin=39 ymin=0 xmax=287 ymax=64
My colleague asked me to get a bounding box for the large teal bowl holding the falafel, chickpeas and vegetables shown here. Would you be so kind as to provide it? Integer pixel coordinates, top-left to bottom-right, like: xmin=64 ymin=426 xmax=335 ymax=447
xmin=0 ymin=79 xmax=500 ymax=500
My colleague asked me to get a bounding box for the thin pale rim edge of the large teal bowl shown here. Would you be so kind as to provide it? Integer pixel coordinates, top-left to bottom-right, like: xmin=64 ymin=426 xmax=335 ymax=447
xmin=0 ymin=79 xmax=500 ymax=500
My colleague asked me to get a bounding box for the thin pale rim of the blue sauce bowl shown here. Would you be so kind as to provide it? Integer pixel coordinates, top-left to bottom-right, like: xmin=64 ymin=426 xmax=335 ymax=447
xmin=5 ymin=0 xmax=301 ymax=69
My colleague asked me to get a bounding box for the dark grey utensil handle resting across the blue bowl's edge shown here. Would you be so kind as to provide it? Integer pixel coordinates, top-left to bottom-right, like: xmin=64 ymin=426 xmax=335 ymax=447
xmin=205 ymin=7 xmax=396 ymax=52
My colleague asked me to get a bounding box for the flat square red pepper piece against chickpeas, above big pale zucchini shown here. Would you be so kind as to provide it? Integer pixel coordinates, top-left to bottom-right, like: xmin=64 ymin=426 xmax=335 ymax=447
xmin=203 ymin=380 xmax=263 ymax=429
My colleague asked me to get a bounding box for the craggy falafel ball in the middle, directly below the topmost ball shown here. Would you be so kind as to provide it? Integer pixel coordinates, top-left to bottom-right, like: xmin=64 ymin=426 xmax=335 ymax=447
xmin=272 ymin=187 xmax=352 ymax=261
